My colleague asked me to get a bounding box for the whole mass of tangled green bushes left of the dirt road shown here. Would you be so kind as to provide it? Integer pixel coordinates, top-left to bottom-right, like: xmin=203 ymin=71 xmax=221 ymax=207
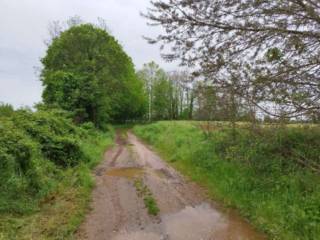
xmin=0 ymin=108 xmax=109 ymax=213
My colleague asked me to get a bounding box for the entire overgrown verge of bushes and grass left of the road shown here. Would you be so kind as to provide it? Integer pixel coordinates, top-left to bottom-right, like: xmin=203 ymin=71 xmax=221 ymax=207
xmin=0 ymin=111 xmax=114 ymax=240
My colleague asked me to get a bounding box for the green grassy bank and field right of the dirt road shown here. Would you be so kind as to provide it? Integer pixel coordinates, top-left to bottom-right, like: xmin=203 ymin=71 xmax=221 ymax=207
xmin=134 ymin=121 xmax=320 ymax=240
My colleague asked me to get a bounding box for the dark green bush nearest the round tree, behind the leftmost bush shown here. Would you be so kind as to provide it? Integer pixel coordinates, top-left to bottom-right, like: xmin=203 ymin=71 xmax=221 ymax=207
xmin=5 ymin=110 xmax=84 ymax=167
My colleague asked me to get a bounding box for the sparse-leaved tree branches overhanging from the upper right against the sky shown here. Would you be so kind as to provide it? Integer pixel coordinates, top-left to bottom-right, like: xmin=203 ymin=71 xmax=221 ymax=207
xmin=144 ymin=0 xmax=320 ymax=117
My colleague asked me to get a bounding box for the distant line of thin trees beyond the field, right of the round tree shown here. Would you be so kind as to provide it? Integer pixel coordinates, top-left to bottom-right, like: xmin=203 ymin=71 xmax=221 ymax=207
xmin=138 ymin=62 xmax=268 ymax=122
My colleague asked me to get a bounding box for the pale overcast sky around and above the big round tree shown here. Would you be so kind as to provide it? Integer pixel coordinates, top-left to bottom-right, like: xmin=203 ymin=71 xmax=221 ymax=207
xmin=0 ymin=0 xmax=175 ymax=107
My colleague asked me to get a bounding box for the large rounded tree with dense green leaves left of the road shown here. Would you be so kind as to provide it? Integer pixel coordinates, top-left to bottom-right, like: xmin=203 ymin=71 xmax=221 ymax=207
xmin=41 ymin=24 xmax=145 ymax=127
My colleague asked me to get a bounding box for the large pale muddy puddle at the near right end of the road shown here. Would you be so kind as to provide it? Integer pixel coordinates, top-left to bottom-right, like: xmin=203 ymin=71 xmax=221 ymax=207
xmin=162 ymin=204 xmax=265 ymax=240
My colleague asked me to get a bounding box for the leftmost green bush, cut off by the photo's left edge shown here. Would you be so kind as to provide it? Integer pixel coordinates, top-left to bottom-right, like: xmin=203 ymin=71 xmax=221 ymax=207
xmin=0 ymin=121 xmax=57 ymax=212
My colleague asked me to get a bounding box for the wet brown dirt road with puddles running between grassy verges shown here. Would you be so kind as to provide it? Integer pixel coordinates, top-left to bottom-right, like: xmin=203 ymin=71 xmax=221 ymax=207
xmin=78 ymin=133 xmax=265 ymax=240
